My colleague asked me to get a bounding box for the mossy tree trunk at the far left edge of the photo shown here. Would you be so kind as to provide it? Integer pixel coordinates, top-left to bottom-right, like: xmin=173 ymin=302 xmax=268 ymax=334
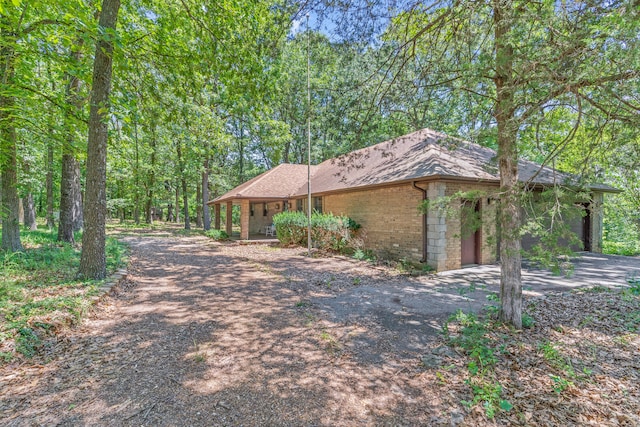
xmin=0 ymin=36 xmax=22 ymax=252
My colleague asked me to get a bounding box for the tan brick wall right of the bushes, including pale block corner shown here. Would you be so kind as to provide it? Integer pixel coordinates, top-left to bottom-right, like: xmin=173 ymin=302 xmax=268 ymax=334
xmin=324 ymin=182 xmax=497 ymax=271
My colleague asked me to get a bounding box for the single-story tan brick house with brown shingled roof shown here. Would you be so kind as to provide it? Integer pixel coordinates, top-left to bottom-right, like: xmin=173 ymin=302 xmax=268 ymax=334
xmin=210 ymin=129 xmax=617 ymax=271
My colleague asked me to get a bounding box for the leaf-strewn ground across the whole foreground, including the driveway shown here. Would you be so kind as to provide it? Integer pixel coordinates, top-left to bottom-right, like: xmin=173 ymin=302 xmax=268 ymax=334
xmin=0 ymin=226 xmax=640 ymax=426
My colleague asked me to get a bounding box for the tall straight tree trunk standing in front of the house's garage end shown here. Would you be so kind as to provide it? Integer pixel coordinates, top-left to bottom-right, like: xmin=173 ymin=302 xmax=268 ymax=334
xmin=493 ymin=0 xmax=522 ymax=329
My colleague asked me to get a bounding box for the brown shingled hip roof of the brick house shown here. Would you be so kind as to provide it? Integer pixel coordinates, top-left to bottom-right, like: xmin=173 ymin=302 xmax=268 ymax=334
xmin=215 ymin=129 xmax=617 ymax=203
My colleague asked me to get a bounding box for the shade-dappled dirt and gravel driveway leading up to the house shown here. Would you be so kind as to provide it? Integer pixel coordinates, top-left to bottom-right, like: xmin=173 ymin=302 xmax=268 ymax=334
xmin=0 ymin=236 xmax=640 ymax=426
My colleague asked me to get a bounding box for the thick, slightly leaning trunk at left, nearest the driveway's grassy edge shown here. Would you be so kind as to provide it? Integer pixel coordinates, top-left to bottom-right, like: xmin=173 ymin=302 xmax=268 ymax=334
xmin=79 ymin=0 xmax=120 ymax=279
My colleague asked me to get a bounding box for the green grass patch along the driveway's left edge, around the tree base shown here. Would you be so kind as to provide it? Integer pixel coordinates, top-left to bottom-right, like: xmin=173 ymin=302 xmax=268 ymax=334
xmin=0 ymin=229 xmax=126 ymax=362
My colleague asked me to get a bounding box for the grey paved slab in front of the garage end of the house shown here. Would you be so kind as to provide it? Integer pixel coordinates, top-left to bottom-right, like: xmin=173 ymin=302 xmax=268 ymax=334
xmin=312 ymin=253 xmax=640 ymax=360
